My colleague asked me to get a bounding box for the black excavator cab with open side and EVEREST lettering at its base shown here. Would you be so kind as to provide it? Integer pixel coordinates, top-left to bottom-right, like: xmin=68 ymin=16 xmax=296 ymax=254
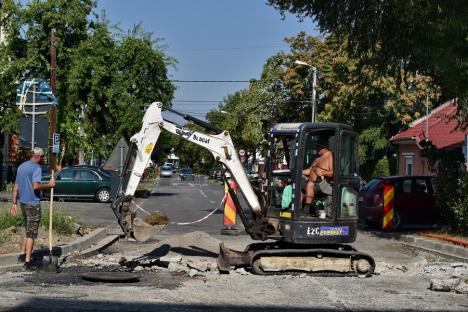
xmin=264 ymin=123 xmax=359 ymax=244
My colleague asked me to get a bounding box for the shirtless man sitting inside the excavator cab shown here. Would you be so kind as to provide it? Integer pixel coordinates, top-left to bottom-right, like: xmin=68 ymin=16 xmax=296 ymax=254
xmin=302 ymin=143 xmax=333 ymax=216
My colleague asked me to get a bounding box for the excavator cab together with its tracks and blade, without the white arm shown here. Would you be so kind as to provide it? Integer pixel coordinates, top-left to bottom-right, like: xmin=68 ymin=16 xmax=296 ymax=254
xmin=218 ymin=123 xmax=375 ymax=276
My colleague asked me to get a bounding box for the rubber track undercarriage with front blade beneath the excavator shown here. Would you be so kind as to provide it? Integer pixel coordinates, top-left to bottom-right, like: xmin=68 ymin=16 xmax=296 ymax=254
xmin=218 ymin=243 xmax=375 ymax=277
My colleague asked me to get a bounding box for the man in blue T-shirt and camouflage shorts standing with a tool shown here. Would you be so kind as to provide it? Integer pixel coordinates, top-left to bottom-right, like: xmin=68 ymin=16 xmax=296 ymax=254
xmin=10 ymin=147 xmax=55 ymax=269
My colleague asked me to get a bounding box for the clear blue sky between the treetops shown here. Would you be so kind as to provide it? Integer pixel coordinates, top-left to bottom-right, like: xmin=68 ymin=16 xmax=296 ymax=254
xmin=97 ymin=0 xmax=317 ymax=118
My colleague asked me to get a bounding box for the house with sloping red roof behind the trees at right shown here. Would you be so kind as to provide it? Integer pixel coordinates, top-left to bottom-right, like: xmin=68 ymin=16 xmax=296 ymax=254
xmin=390 ymin=99 xmax=467 ymax=176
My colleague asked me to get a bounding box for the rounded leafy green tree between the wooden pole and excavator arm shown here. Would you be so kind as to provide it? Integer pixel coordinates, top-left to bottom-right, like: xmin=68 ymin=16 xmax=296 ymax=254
xmin=63 ymin=23 xmax=174 ymax=161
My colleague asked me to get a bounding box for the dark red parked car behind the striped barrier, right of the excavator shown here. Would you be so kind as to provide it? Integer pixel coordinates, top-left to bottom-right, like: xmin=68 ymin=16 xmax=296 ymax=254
xmin=359 ymin=176 xmax=441 ymax=228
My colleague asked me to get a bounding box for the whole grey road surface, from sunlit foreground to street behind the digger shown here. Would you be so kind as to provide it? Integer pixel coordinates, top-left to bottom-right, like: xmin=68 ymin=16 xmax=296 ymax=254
xmin=0 ymin=179 xmax=468 ymax=312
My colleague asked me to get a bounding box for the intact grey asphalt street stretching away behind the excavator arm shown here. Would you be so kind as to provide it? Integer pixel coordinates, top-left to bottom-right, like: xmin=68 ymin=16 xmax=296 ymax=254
xmin=57 ymin=178 xmax=232 ymax=234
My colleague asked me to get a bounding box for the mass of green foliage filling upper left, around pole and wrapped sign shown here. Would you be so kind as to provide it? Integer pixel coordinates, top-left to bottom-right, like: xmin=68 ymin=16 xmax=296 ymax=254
xmin=0 ymin=0 xmax=175 ymax=165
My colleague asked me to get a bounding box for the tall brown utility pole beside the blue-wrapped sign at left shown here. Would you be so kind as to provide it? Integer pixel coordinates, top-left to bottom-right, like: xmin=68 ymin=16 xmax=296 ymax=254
xmin=49 ymin=28 xmax=57 ymax=172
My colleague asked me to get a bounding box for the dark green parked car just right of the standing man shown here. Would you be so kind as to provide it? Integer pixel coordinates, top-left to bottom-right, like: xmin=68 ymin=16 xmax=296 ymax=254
xmin=42 ymin=166 xmax=111 ymax=203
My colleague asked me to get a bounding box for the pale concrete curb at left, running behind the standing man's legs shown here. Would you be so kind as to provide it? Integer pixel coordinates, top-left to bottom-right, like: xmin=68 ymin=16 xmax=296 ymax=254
xmin=0 ymin=228 xmax=111 ymax=272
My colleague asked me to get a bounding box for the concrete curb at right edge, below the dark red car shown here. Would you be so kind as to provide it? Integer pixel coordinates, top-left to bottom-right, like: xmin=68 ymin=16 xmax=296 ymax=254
xmin=399 ymin=235 xmax=468 ymax=262
